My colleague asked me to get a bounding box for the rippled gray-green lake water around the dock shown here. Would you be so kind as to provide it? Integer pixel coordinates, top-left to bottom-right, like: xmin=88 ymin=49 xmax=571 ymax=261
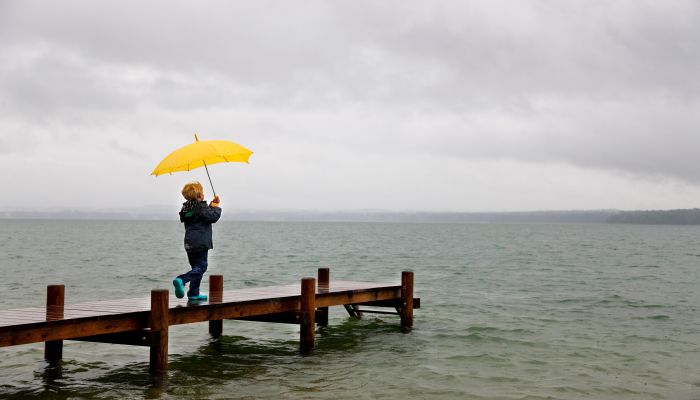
xmin=0 ymin=220 xmax=700 ymax=399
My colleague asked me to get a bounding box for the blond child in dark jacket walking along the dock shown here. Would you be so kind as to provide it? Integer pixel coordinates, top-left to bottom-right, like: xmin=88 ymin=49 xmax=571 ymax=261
xmin=173 ymin=182 xmax=221 ymax=300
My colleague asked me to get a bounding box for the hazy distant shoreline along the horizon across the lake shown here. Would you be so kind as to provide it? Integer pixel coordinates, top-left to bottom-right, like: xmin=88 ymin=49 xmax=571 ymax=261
xmin=0 ymin=208 xmax=700 ymax=225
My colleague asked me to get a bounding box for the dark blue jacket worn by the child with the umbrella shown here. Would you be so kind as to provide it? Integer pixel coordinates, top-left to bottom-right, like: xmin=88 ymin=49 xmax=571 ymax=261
xmin=180 ymin=200 xmax=221 ymax=253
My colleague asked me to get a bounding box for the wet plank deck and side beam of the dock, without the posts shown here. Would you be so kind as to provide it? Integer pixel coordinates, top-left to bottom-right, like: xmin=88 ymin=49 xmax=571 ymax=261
xmin=0 ymin=281 xmax=402 ymax=347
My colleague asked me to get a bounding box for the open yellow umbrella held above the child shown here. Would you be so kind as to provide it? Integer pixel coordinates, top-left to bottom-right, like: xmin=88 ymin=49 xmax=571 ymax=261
xmin=151 ymin=134 xmax=253 ymax=195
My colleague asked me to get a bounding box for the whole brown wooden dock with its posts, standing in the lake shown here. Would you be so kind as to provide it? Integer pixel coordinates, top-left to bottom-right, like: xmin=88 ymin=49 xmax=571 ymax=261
xmin=0 ymin=268 xmax=420 ymax=372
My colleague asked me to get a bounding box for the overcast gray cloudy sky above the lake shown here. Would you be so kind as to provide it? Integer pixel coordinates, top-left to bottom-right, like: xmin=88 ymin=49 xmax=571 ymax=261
xmin=0 ymin=0 xmax=700 ymax=211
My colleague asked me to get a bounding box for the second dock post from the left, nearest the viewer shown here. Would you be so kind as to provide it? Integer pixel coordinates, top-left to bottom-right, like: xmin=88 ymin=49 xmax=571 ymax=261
xmin=149 ymin=289 xmax=169 ymax=372
